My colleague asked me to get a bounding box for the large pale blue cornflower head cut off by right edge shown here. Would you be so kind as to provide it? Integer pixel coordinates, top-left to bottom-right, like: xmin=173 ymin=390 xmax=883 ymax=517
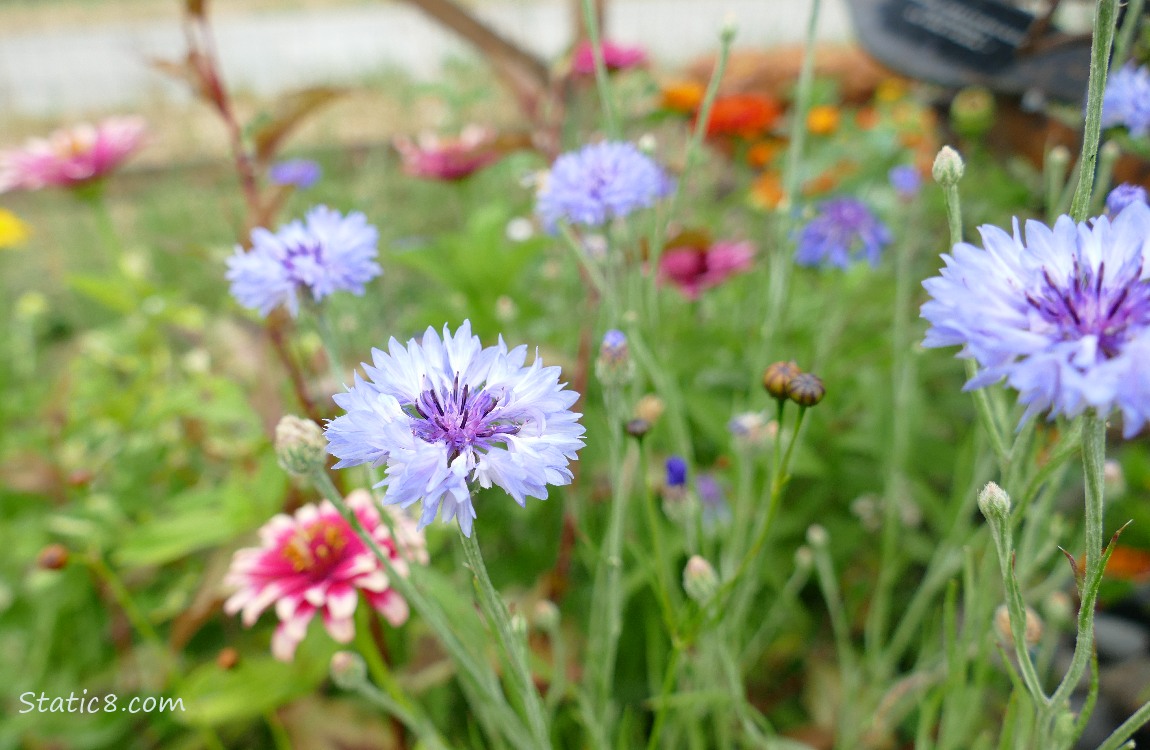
xmin=922 ymin=204 xmax=1150 ymax=437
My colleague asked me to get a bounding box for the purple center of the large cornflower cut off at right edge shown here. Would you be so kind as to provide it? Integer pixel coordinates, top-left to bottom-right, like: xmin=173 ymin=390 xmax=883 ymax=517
xmin=1026 ymin=261 xmax=1150 ymax=359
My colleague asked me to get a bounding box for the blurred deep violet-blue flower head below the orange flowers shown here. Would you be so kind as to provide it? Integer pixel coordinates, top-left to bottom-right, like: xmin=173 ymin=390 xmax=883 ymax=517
xmin=795 ymin=198 xmax=890 ymax=268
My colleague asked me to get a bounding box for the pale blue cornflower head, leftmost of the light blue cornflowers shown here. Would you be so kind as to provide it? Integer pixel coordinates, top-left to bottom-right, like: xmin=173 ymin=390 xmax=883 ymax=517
xmin=228 ymin=206 xmax=382 ymax=316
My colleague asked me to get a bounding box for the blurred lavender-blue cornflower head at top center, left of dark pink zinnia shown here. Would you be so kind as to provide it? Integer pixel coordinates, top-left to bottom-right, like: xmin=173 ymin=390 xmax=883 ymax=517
xmin=535 ymin=141 xmax=674 ymax=231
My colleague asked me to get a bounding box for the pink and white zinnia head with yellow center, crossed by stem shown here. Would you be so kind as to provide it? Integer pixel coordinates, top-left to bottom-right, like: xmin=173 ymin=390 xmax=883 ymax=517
xmin=223 ymin=490 xmax=428 ymax=661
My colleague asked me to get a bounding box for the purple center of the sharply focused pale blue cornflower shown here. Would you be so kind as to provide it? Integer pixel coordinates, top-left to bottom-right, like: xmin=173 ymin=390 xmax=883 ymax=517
xmin=408 ymin=375 xmax=520 ymax=464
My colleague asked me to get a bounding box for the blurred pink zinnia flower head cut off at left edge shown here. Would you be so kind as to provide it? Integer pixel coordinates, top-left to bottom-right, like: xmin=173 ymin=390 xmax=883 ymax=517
xmin=0 ymin=116 xmax=146 ymax=193
